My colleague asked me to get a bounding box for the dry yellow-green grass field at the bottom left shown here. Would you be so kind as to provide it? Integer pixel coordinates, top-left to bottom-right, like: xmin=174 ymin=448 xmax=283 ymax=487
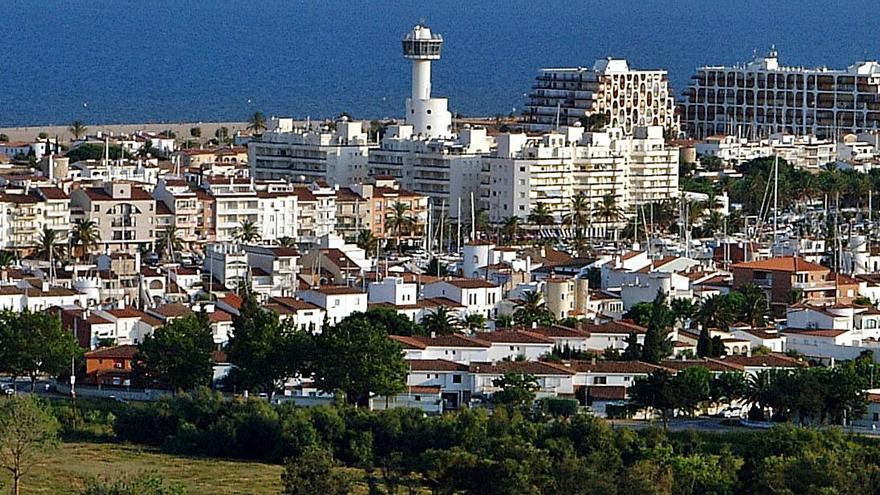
xmin=6 ymin=443 xmax=282 ymax=495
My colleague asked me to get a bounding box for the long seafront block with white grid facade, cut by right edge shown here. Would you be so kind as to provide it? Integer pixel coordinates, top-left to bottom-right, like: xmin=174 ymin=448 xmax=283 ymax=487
xmin=682 ymin=49 xmax=880 ymax=138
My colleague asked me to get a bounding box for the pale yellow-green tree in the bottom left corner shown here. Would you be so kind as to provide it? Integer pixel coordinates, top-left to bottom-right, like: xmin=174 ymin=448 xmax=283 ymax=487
xmin=0 ymin=396 xmax=58 ymax=495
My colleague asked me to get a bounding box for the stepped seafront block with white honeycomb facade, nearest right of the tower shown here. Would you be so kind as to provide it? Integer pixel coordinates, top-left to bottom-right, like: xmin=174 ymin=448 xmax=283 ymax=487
xmin=522 ymin=57 xmax=678 ymax=133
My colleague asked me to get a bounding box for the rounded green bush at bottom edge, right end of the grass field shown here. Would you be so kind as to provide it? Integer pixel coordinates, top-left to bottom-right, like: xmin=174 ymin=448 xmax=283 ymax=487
xmin=281 ymin=446 xmax=352 ymax=495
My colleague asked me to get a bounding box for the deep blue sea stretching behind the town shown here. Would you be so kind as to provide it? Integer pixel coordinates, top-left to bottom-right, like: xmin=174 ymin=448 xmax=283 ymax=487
xmin=0 ymin=0 xmax=880 ymax=126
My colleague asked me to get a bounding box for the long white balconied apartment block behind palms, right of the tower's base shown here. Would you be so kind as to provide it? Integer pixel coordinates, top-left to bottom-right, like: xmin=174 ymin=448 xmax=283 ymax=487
xmin=481 ymin=124 xmax=678 ymax=222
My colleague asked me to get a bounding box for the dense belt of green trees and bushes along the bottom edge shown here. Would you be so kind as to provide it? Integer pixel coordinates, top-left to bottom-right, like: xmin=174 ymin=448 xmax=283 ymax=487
xmin=44 ymin=390 xmax=880 ymax=495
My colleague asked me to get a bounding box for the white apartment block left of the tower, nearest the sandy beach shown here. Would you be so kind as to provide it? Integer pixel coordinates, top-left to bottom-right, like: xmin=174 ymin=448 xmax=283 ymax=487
xmin=248 ymin=117 xmax=377 ymax=186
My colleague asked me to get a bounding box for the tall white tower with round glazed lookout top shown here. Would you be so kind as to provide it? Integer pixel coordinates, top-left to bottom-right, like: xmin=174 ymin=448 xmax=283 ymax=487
xmin=403 ymin=24 xmax=452 ymax=138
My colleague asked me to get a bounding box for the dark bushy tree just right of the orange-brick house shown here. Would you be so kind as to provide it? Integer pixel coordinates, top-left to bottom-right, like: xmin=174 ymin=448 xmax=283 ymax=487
xmin=132 ymin=314 xmax=214 ymax=392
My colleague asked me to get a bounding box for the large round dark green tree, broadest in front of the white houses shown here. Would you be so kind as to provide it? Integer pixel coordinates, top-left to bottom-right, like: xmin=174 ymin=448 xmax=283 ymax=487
xmin=313 ymin=313 xmax=409 ymax=405
